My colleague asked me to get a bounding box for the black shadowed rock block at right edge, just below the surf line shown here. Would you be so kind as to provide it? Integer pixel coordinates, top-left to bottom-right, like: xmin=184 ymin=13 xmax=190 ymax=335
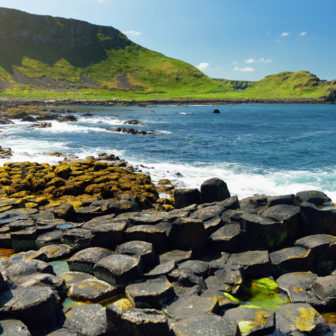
xmin=301 ymin=202 xmax=336 ymax=236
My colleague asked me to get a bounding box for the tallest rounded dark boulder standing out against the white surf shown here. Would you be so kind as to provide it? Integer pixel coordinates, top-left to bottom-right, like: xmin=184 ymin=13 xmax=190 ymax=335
xmin=201 ymin=178 xmax=231 ymax=203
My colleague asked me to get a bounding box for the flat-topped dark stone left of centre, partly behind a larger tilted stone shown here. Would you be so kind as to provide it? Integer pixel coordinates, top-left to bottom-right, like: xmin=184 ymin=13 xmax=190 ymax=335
xmin=115 ymin=240 xmax=157 ymax=268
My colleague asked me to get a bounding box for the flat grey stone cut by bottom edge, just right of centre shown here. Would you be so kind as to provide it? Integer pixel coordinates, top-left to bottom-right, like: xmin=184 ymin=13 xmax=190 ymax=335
xmin=171 ymin=315 xmax=240 ymax=336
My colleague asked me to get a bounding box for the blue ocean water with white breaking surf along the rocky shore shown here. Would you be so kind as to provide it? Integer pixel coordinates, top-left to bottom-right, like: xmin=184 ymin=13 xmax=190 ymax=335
xmin=0 ymin=104 xmax=336 ymax=201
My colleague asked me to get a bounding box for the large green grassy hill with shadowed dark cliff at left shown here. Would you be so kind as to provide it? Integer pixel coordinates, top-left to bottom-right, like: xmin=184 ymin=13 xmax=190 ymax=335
xmin=0 ymin=8 xmax=226 ymax=95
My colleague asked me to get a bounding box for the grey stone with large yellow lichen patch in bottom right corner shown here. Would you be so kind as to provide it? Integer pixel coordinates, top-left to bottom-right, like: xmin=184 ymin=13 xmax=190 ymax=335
xmin=276 ymin=303 xmax=330 ymax=336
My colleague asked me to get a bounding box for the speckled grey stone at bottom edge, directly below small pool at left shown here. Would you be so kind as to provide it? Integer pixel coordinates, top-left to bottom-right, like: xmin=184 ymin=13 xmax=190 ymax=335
xmin=62 ymin=304 xmax=107 ymax=336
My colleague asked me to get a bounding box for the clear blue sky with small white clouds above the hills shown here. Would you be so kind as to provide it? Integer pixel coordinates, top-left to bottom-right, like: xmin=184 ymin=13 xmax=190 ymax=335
xmin=0 ymin=0 xmax=336 ymax=80
